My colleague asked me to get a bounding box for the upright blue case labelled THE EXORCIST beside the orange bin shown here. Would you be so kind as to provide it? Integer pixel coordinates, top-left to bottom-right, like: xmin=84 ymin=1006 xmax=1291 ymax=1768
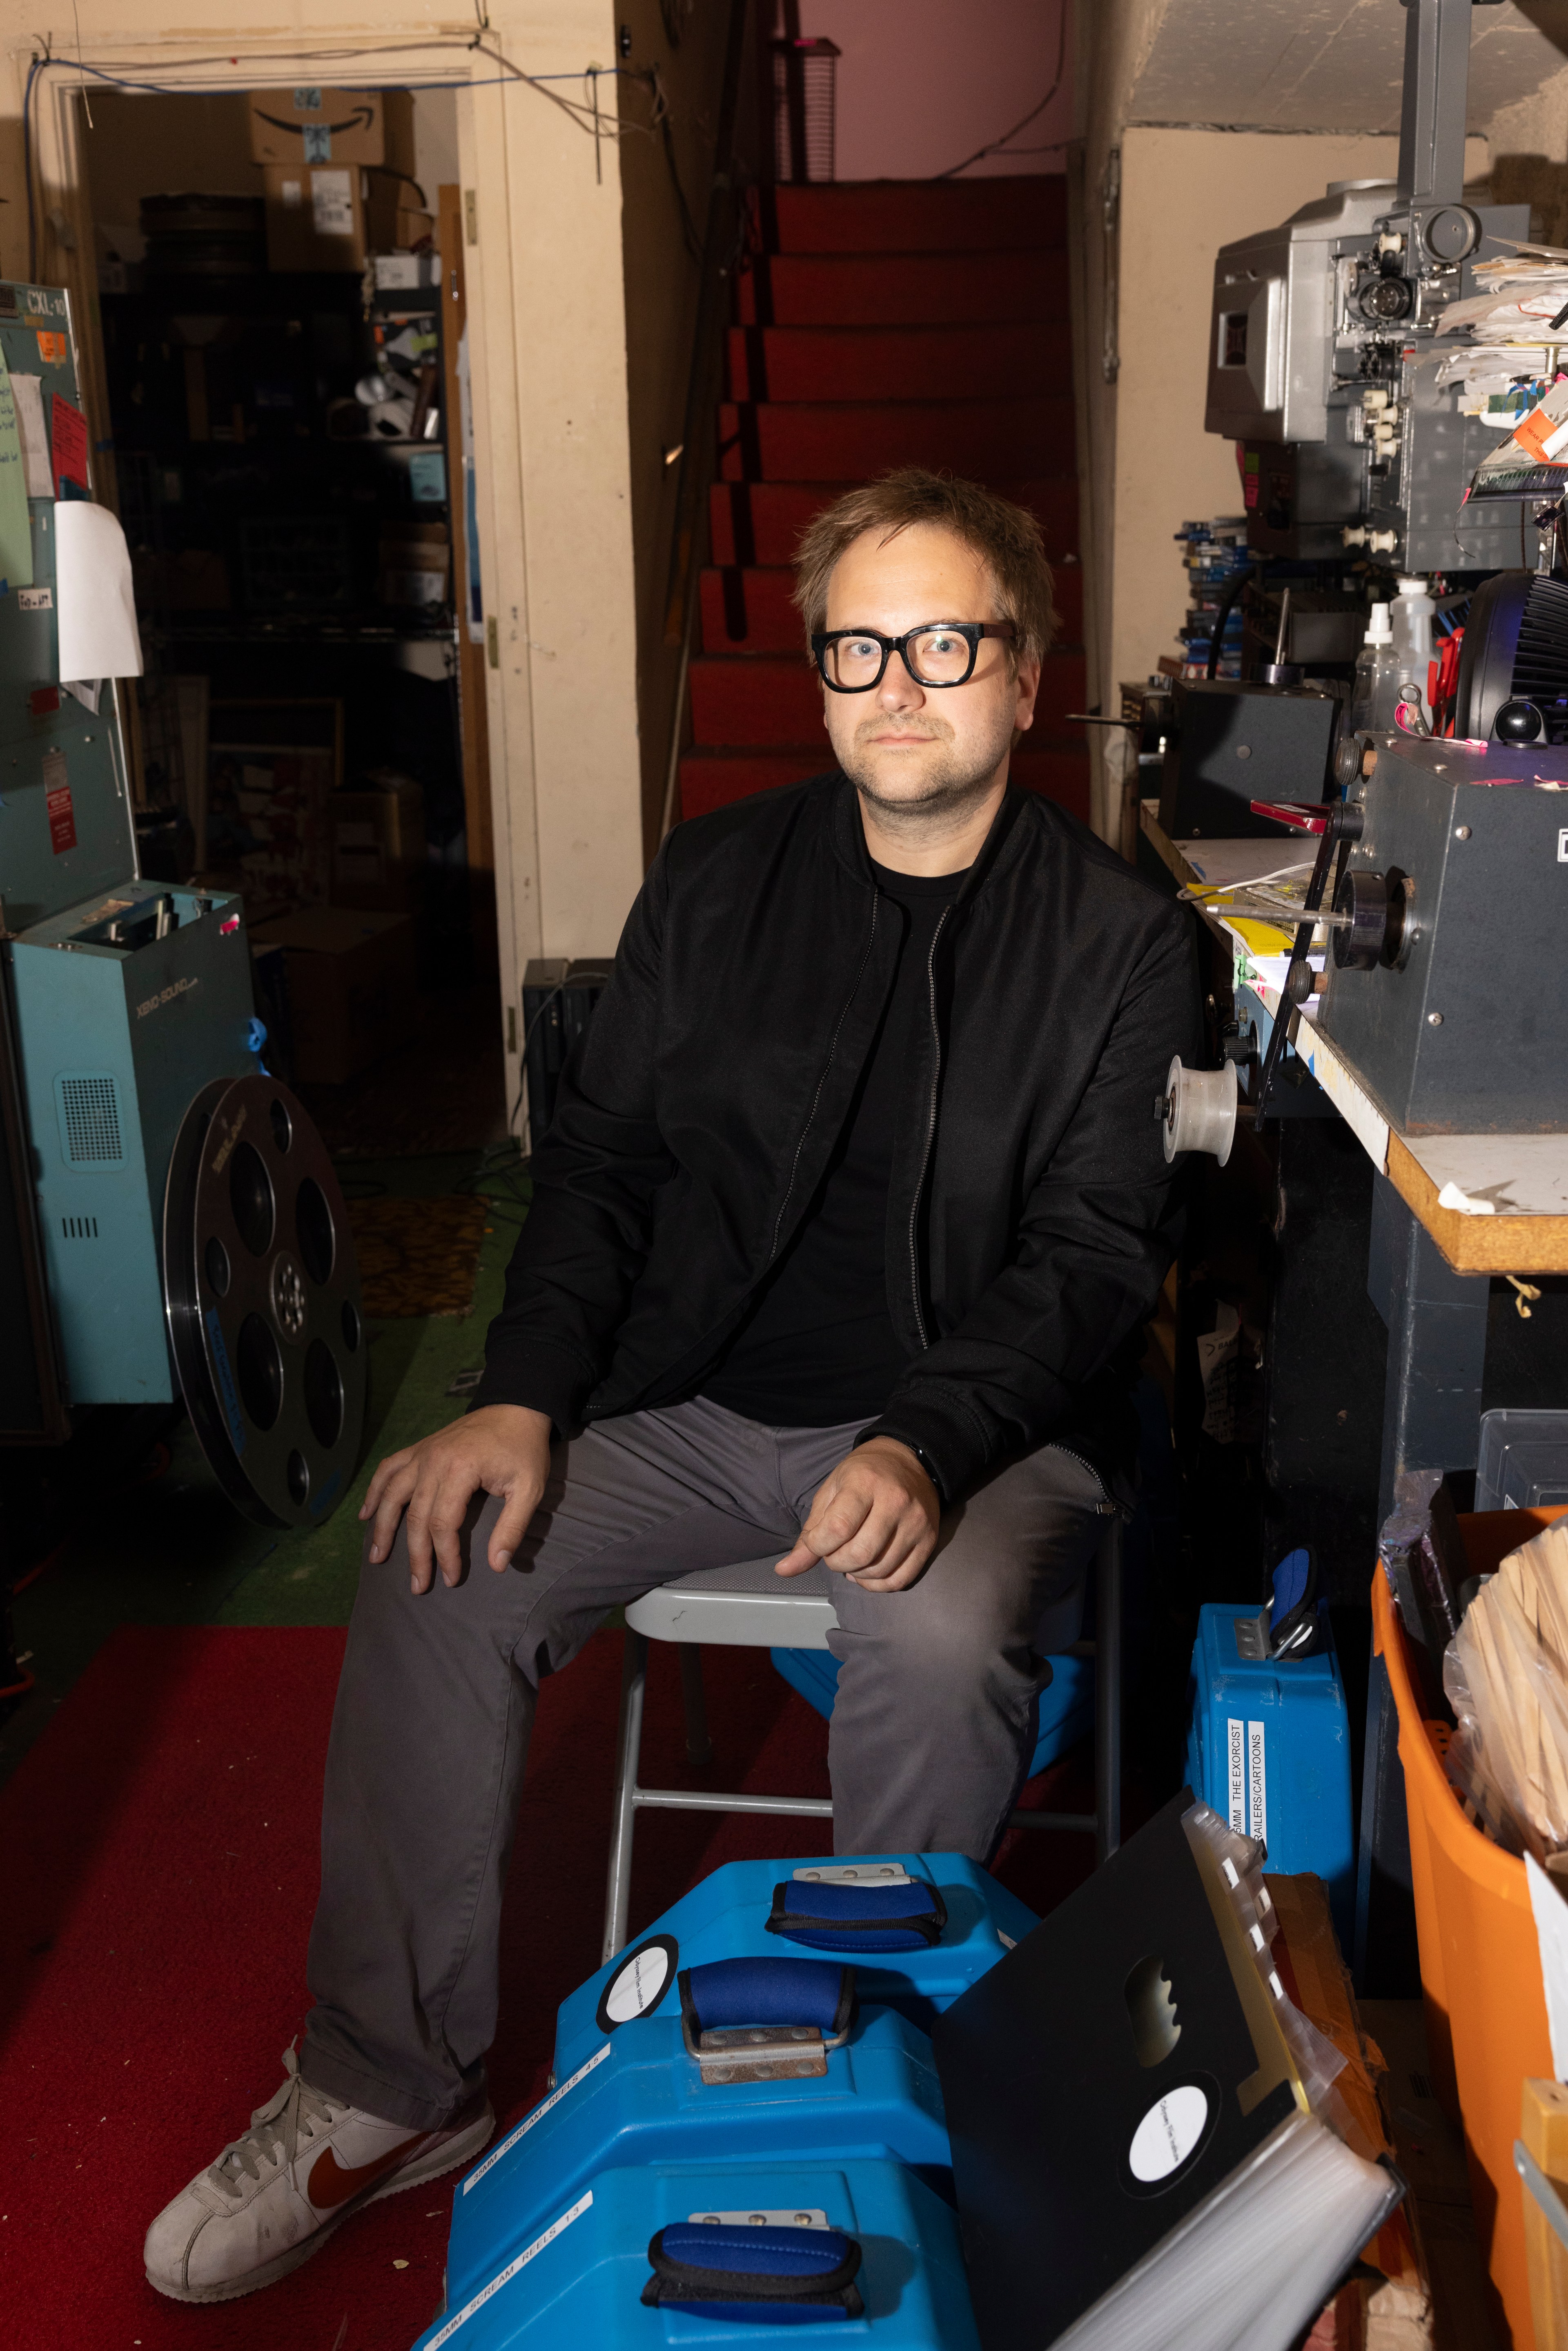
xmin=1187 ymin=1603 xmax=1356 ymax=1947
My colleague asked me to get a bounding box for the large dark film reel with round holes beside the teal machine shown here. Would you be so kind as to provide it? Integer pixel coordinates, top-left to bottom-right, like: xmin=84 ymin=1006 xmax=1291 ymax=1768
xmin=165 ymin=1077 xmax=367 ymax=1526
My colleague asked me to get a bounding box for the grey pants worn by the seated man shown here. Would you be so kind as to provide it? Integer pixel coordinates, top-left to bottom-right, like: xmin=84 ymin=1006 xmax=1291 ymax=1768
xmin=301 ymin=1399 xmax=1105 ymax=2130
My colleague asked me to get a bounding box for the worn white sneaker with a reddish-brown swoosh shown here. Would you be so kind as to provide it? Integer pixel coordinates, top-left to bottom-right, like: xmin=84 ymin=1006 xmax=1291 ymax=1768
xmin=143 ymin=2048 xmax=496 ymax=2302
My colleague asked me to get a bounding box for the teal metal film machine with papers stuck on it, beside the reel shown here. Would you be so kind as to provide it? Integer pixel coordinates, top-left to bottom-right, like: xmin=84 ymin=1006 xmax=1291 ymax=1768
xmin=0 ymin=285 xmax=256 ymax=1404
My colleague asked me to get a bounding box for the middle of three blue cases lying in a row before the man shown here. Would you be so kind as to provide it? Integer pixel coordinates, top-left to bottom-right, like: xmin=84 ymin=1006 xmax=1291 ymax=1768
xmin=447 ymin=1959 xmax=952 ymax=2304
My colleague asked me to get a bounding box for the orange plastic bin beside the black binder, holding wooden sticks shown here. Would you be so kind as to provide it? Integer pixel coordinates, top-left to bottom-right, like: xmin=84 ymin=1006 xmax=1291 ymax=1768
xmin=1373 ymin=1509 xmax=1561 ymax=2351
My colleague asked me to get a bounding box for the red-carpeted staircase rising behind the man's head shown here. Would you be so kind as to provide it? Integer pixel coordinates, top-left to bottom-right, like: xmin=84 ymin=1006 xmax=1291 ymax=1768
xmin=679 ymin=179 xmax=1089 ymax=818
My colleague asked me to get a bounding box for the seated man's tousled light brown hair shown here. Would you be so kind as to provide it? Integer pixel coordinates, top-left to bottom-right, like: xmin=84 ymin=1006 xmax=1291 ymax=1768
xmin=795 ymin=466 xmax=1056 ymax=665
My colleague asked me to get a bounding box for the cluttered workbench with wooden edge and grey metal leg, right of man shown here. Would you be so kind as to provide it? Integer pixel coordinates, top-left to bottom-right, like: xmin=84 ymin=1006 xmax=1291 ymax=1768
xmin=1140 ymin=799 xmax=1568 ymax=1996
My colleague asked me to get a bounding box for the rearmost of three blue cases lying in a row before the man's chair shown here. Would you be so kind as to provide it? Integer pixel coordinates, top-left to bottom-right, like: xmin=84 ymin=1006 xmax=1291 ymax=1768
xmin=552 ymin=1853 xmax=1039 ymax=2083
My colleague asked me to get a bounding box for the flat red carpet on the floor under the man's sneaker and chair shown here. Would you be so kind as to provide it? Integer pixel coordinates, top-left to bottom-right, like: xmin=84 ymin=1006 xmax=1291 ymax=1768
xmin=0 ymin=1627 xmax=1093 ymax=2351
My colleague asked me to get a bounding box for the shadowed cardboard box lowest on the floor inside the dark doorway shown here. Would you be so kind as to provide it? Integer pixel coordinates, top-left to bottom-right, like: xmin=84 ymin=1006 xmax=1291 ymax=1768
xmin=252 ymin=905 xmax=414 ymax=1086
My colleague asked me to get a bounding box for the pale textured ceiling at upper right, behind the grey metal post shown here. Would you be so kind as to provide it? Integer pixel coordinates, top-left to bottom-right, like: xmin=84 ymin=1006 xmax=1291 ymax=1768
xmin=1128 ymin=0 xmax=1568 ymax=131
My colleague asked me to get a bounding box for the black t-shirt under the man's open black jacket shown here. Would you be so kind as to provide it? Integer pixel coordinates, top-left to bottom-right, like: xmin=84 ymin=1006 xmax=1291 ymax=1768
xmin=703 ymin=865 xmax=964 ymax=1429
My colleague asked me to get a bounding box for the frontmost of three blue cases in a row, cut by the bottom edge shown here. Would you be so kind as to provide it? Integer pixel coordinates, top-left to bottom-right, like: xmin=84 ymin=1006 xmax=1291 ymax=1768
xmin=414 ymin=2158 xmax=978 ymax=2351
